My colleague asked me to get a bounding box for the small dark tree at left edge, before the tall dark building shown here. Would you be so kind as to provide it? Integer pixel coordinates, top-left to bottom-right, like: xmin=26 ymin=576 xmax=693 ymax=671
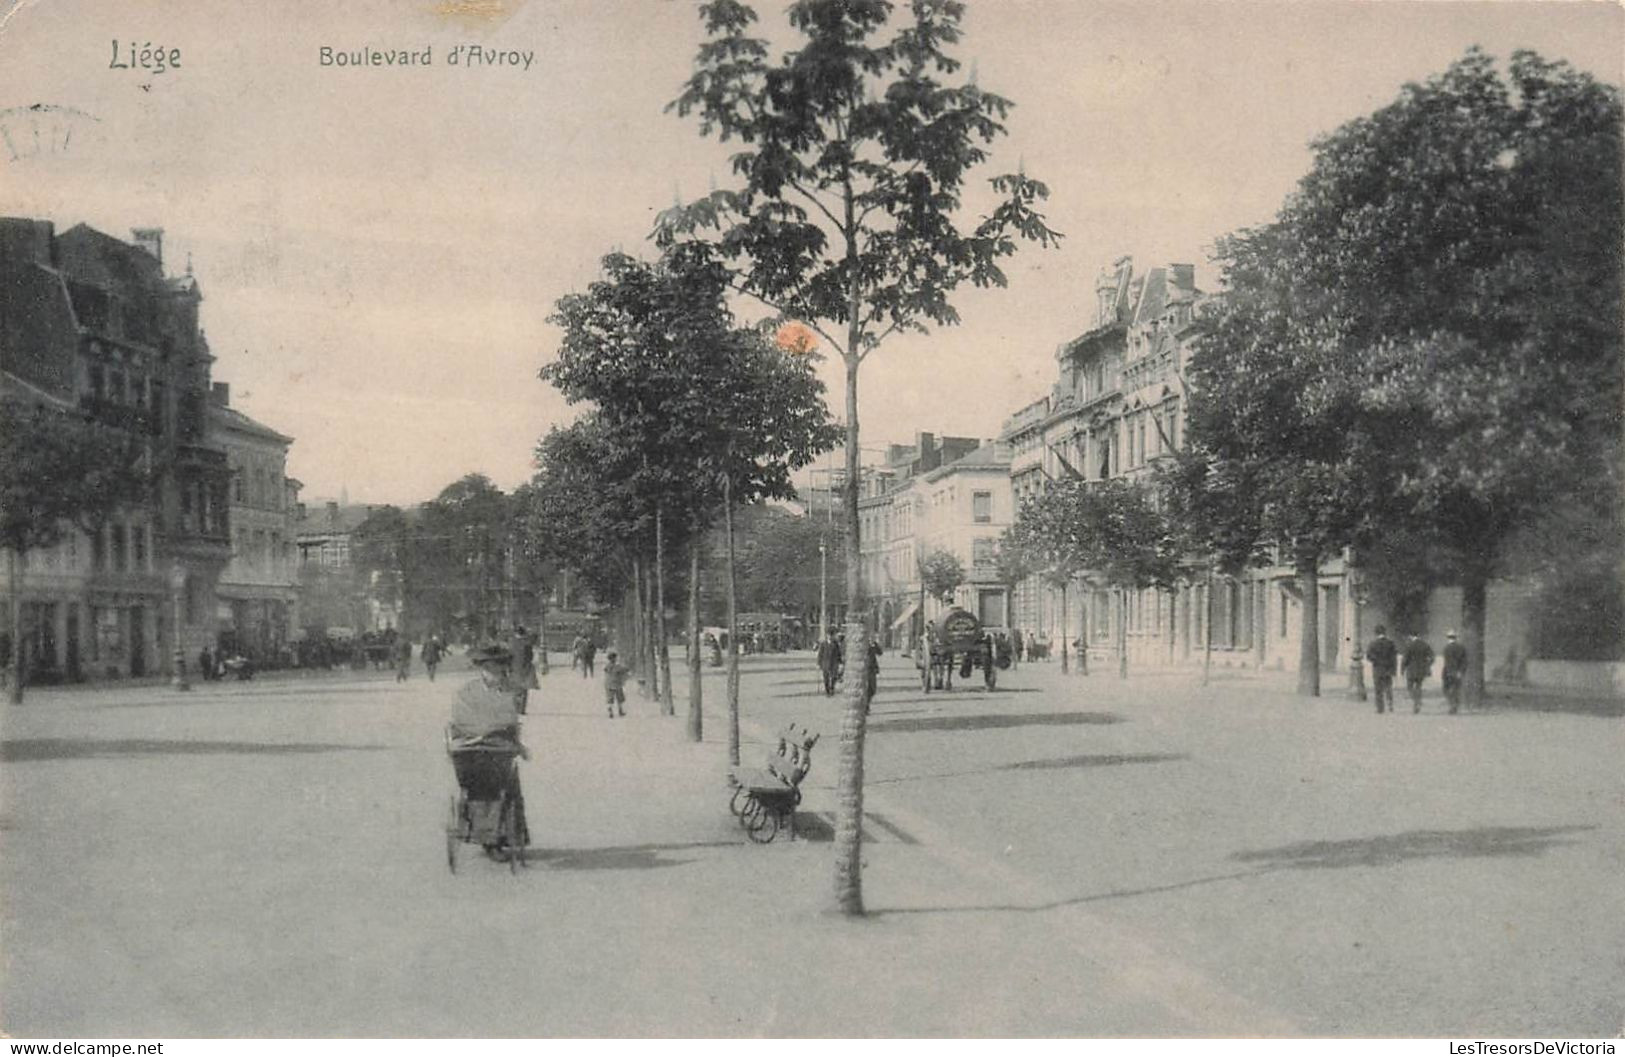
xmin=0 ymin=400 xmax=153 ymax=704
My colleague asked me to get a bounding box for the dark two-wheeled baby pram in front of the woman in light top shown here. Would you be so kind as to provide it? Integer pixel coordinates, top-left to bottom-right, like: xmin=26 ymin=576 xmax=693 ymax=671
xmin=445 ymin=725 xmax=530 ymax=873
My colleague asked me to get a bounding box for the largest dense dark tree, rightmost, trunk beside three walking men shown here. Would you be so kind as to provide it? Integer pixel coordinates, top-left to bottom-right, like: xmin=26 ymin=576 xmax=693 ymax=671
xmin=1191 ymin=49 xmax=1625 ymax=704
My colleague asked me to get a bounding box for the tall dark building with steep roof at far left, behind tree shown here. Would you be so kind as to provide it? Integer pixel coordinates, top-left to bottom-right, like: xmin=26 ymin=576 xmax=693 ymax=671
xmin=0 ymin=218 xmax=242 ymax=681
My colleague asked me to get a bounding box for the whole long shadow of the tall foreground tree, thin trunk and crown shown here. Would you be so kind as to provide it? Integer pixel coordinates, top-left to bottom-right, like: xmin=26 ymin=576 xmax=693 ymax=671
xmin=869 ymin=826 xmax=1596 ymax=917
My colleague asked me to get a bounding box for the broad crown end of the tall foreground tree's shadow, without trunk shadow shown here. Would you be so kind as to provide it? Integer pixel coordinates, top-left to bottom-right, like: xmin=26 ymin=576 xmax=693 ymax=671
xmin=1230 ymin=826 xmax=1596 ymax=870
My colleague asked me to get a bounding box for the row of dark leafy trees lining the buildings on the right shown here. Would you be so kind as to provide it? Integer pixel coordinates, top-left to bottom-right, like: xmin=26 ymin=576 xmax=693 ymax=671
xmin=1004 ymin=50 xmax=1625 ymax=702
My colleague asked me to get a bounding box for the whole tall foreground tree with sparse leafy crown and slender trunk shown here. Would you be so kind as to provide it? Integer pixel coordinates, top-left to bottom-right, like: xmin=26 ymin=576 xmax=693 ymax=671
xmin=657 ymin=0 xmax=1060 ymax=914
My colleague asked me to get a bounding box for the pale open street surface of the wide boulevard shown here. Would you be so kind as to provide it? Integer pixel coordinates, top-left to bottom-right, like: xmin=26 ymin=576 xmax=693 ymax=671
xmin=0 ymin=654 xmax=1625 ymax=1037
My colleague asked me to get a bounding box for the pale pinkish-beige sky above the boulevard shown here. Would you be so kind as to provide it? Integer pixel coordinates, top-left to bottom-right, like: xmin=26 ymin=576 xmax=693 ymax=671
xmin=0 ymin=0 xmax=1625 ymax=504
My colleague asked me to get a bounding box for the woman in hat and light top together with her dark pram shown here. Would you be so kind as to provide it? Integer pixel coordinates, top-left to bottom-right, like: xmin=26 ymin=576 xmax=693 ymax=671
xmin=445 ymin=646 xmax=530 ymax=872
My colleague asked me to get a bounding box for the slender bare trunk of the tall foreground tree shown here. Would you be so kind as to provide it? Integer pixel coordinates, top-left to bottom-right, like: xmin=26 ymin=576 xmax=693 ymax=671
xmin=835 ymin=339 xmax=869 ymax=917
